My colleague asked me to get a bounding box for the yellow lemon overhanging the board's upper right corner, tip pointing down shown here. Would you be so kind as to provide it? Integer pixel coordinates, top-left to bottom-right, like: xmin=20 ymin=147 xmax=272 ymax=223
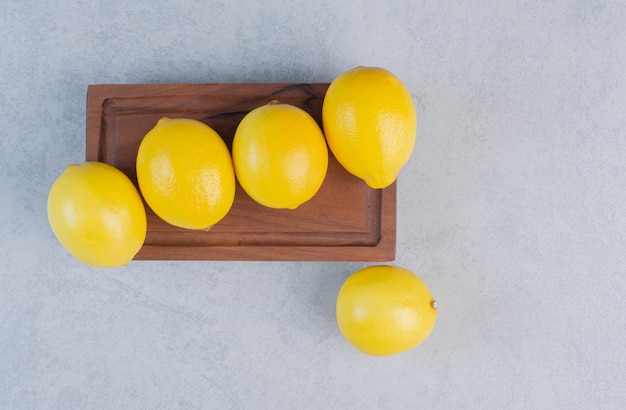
xmin=322 ymin=67 xmax=417 ymax=189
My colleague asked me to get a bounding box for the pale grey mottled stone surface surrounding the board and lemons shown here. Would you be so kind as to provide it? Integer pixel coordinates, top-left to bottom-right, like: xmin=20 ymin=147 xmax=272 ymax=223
xmin=0 ymin=0 xmax=626 ymax=409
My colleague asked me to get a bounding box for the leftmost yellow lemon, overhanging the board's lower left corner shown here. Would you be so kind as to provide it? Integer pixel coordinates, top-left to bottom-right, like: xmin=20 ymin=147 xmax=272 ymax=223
xmin=47 ymin=162 xmax=147 ymax=268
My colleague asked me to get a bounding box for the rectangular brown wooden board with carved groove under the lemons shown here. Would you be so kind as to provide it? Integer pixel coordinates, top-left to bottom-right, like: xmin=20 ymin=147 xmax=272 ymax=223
xmin=86 ymin=83 xmax=396 ymax=261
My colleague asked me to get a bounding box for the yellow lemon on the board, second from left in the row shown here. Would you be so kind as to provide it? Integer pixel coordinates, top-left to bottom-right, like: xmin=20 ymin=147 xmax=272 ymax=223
xmin=136 ymin=117 xmax=235 ymax=230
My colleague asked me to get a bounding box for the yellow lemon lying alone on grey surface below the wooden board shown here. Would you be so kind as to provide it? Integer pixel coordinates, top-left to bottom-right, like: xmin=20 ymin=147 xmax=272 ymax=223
xmin=336 ymin=265 xmax=437 ymax=356
